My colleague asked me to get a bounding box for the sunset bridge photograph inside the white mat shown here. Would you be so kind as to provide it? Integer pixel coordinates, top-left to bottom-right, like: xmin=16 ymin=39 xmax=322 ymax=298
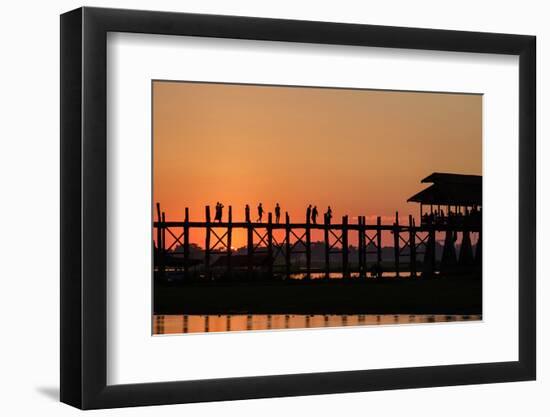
xmin=151 ymin=80 xmax=483 ymax=335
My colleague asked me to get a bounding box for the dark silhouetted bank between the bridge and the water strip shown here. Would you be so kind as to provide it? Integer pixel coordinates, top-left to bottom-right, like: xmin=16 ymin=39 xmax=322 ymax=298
xmin=154 ymin=276 xmax=482 ymax=314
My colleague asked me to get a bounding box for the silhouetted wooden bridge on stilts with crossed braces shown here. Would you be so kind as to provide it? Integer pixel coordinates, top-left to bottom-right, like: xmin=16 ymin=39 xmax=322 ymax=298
xmin=153 ymin=203 xmax=481 ymax=279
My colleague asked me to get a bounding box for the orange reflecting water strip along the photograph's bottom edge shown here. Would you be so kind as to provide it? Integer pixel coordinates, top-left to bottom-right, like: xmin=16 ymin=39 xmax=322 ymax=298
xmin=153 ymin=314 xmax=481 ymax=334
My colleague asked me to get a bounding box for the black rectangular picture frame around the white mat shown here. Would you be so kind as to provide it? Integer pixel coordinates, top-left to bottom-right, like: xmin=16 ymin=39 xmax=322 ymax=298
xmin=60 ymin=7 xmax=536 ymax=409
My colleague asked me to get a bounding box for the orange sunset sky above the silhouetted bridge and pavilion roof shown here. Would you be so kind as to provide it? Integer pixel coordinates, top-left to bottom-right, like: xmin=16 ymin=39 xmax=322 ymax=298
xmin=153 ymin=81 xmax=482 ymax=247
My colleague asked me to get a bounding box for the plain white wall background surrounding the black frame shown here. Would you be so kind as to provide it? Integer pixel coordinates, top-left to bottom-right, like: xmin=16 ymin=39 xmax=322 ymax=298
xmin=0 ymin=0 xmax=550 ymax=417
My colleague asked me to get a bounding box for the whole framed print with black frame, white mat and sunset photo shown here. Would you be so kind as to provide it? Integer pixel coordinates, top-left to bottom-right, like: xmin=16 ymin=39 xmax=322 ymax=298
xmin=61 ymin=8 xmax=536 ymax=409
